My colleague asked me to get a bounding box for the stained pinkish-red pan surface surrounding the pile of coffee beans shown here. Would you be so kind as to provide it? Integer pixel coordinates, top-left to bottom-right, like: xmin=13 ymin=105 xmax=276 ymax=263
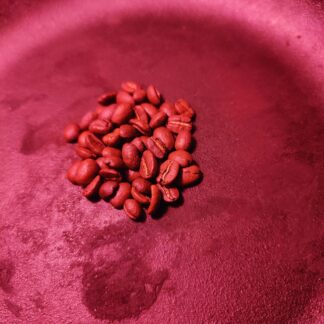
xmin=0 ymin=0 xmax=324 ymax=323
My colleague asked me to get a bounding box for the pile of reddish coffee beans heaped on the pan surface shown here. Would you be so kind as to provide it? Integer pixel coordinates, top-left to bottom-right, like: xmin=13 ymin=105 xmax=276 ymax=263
xmin=64 ymin=81 xmax=202 ymax=220
